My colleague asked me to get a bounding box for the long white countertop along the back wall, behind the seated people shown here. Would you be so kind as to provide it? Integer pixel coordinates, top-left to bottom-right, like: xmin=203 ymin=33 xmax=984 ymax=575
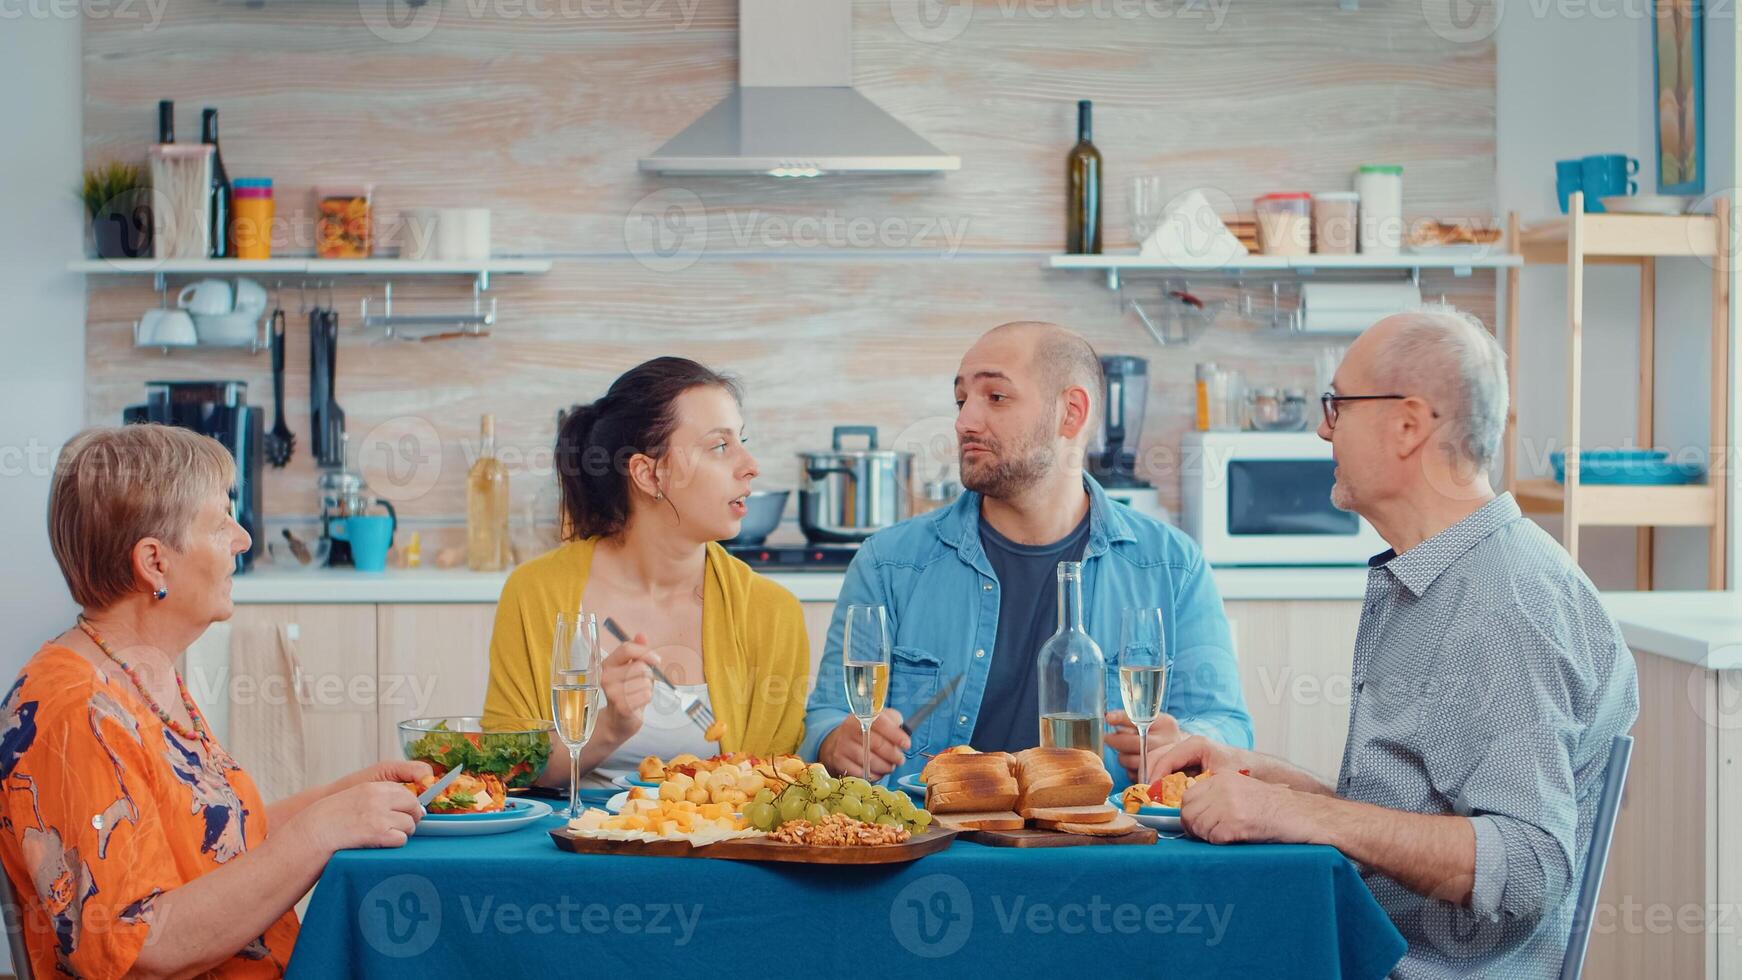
xmin=232 ymin=567 xmax=1367 ymax=604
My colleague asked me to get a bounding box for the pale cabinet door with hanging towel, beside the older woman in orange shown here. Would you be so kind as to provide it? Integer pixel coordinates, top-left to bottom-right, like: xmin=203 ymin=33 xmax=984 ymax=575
xmin=223 ymin=604 xmax=378 ymax=799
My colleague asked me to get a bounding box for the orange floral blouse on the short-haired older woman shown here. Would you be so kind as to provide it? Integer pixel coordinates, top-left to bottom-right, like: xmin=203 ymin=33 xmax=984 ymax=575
xmin=0 ymin=644 xmax=296 ymax=977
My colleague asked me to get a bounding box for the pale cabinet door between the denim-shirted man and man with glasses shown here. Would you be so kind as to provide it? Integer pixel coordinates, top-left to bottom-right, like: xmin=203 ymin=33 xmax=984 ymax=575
xmin=1225 ymin=601 xmax=1361 ymax=785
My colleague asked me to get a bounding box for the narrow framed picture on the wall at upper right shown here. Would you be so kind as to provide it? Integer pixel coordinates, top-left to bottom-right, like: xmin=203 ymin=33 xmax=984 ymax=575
xmin=1651 ymin=0 xmax=1705 ymax=195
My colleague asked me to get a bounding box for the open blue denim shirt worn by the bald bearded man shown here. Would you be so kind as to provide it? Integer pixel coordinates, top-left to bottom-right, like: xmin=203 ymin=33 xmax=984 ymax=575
xmin=800 ymin=475 xmax=1252 ymax=785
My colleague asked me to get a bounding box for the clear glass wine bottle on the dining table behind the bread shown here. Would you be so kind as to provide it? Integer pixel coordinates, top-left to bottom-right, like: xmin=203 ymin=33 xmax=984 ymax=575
xmin=1036 ymin=562 xmax=1106 ymax=757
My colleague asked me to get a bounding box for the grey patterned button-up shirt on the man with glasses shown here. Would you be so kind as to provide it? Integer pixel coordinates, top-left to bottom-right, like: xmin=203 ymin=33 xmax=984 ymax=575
xmin=1336 ymin=494 xmax=1639 ymax=980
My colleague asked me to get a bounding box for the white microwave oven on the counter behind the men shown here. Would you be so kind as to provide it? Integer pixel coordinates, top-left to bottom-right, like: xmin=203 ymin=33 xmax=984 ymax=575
xmin=1179 ymin=432 xmax=1388 ymax=566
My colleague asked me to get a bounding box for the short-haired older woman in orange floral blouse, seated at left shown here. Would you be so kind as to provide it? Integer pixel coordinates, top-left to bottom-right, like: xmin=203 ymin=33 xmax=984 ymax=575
xmin=0 ymin=425 xmax=429 ymax=977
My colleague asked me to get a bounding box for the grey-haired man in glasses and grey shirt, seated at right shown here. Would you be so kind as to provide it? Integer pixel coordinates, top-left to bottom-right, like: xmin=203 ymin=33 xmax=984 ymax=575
xmin=1160 ymin=308 xmax=1639 ymax=980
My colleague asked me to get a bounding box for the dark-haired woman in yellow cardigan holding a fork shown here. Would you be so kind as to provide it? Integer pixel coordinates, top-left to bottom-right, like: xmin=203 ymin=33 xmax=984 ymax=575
xmin=484 ymin=357 xmax=810 ymax=787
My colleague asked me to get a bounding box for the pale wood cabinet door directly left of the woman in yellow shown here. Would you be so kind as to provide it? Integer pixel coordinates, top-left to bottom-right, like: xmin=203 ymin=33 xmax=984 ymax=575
xmin=373 ymin=602 xmax=496 ymax=759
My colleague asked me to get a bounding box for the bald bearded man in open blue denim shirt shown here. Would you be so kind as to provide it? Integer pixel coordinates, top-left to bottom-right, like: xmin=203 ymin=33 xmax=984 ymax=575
xmin=801 ymin=322 xmax=1252 ymax=785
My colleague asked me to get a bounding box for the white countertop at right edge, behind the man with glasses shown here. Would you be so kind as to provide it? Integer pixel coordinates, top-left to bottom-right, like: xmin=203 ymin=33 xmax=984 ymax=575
xmin=1603 ymin=592 xmax=1742 ymax=670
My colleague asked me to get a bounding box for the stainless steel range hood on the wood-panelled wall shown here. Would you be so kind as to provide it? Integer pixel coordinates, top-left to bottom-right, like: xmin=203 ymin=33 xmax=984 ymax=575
xmin=641 ymin=0 xmax=962 ymax=178
